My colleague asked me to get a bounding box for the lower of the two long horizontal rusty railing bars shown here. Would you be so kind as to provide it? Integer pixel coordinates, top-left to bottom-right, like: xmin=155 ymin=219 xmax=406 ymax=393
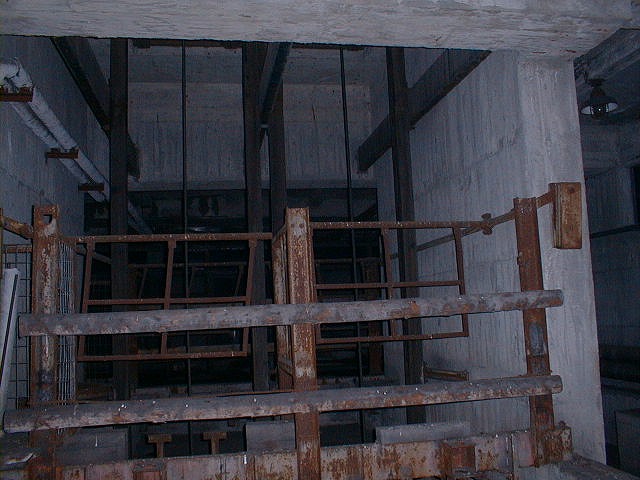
xmin=4 ymin=375 xmax=562 ymax=433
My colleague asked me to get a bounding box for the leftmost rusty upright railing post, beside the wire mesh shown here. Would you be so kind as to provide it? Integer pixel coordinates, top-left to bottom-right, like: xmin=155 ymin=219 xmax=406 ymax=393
xmin=30 ymin=206 xmax=60 ymax=480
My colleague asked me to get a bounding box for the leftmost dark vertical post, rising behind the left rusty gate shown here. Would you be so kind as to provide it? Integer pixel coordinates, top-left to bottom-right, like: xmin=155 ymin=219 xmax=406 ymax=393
xmin=109 ymin=38 xmax=134 ymax=399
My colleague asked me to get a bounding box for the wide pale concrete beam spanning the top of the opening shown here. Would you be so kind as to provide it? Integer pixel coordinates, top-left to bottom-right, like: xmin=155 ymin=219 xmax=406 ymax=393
xmin=0 ymin=0 xmax=633 ymax=57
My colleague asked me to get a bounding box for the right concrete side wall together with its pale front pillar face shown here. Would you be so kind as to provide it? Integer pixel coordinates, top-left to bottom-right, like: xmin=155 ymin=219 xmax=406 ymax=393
xmin=378 ymin=52 xmax=604 ymax=460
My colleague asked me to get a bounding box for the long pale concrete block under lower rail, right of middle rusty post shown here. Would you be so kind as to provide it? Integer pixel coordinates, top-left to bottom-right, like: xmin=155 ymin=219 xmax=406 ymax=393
xmin=376 ymin=422 xmax=471 ymax=444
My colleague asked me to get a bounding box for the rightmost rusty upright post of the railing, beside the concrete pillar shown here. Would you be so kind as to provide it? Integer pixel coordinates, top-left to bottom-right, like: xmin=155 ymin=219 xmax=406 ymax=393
xmin=513 ymin=198 xmax=554 ymax=465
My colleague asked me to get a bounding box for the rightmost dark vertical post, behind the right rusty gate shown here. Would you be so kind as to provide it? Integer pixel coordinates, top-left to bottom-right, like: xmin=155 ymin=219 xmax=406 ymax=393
xmin=387 ymin=47 xmax=426 ymax=423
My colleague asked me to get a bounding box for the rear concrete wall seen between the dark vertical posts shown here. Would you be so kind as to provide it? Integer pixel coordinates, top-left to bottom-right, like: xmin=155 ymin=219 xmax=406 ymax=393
xmin=130 ymin=83 xmax=373 ymax=189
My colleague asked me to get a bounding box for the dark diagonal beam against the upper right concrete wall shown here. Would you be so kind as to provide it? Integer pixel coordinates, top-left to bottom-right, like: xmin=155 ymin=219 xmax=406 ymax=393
xmin=358 ymin=50 xmax=490 ymax=170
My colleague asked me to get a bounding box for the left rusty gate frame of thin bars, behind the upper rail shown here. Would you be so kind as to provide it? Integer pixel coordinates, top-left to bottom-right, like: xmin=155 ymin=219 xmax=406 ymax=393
xmin=74 ymin=233 xmax=271 ymax=362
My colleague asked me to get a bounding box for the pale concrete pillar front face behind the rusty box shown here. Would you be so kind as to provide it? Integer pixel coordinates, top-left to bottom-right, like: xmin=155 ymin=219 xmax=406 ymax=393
xmin=517 ymin=53 xmax=605 ymax=461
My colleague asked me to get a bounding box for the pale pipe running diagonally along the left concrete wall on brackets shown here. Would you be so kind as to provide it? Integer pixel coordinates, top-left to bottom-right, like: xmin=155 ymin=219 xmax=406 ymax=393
xmin=0 ymin=59 xmax=151 ymax=233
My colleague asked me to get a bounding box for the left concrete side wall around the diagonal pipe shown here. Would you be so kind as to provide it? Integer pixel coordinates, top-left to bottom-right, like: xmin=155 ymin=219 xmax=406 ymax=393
xmin=0 ymin=36 xmax=108 ymax=237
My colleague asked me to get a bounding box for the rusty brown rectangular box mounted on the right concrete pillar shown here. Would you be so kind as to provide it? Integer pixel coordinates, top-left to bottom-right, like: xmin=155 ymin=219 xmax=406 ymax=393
xmin=549 ymin=182 xmax=582 ymax=250
